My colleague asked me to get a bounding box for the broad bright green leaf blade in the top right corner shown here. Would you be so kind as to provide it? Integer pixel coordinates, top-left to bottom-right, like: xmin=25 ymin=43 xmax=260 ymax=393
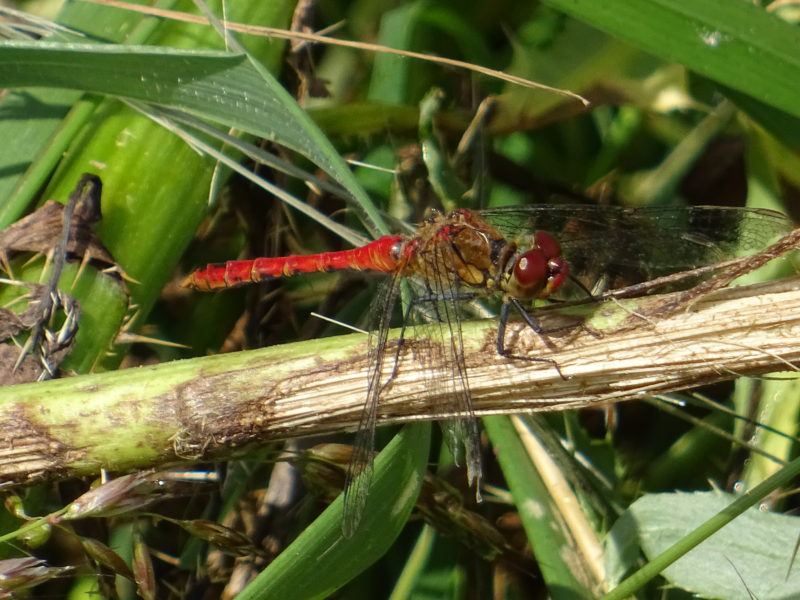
xmin=544 ymin=0 xmax=800 ymax=117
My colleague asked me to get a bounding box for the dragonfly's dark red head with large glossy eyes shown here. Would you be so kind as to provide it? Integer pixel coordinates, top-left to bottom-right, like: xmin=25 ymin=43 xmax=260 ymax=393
xmin=505 ymin=231 xmax=569 ymax=300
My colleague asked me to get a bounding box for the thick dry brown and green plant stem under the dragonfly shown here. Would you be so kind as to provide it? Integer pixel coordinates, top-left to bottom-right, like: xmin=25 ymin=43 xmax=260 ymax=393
xmin=0 ymin=278 xmax=800 ymax=488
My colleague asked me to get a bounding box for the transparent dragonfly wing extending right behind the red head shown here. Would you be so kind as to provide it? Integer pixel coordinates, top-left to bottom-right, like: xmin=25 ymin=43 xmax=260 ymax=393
xmin=481 ymin=205 xmax=793 ymax=288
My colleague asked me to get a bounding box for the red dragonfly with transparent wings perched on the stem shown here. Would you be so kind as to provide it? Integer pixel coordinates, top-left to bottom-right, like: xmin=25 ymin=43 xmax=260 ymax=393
xmin=183 ymin=205 xmax=792 ymax=535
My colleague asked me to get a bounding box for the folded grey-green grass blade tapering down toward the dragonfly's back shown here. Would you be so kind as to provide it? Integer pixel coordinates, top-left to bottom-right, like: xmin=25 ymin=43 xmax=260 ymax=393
xmin=0 ymin=41 xmax=386 ymax=233
